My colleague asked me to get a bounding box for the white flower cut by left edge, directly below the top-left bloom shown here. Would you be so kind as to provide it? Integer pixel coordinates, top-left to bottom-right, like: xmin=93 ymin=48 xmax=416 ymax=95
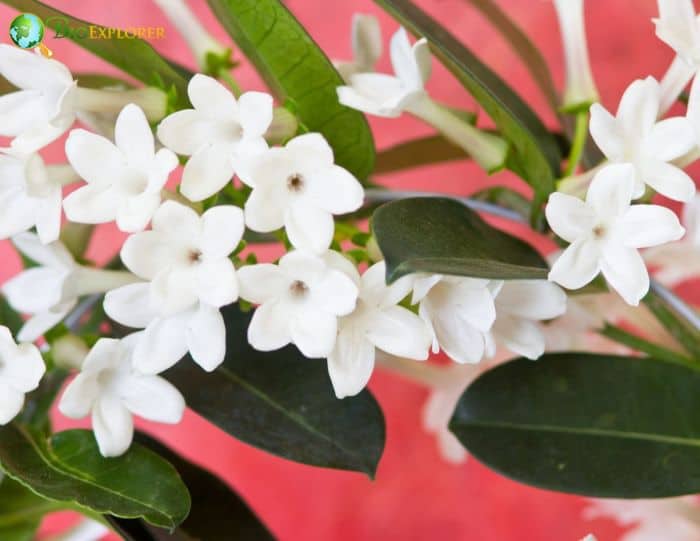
xmin=0 ymin=148 xmax=63 ymax=243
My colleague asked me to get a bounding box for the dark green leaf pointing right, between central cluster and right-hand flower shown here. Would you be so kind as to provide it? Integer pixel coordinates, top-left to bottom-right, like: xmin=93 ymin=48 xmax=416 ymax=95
xmin=372 ymin=197 xmax=547 ymax=282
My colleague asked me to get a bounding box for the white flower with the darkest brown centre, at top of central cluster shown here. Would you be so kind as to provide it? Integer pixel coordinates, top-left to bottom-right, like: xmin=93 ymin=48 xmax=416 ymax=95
xmin=238 ymin=133 xmax=364 ymax=253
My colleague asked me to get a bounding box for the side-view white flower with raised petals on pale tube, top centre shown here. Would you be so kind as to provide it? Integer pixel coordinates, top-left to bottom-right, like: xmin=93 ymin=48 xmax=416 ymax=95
xmin=337 ymin=28 xmax=431 ymax=117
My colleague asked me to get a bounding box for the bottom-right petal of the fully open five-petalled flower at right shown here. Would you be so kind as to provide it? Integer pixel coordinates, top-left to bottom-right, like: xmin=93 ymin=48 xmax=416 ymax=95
xmin=600 ymin=245 xmax=649 ymax=306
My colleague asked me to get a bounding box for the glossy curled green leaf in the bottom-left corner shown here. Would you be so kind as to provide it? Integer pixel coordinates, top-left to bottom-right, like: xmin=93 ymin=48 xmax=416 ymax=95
xmin=0 ymin=424 xmax=190 ymax=529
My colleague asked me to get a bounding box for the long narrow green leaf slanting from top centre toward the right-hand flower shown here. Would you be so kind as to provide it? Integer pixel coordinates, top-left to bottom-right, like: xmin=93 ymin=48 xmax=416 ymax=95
xmin=376 ymin=0 xmax=562 ymax=211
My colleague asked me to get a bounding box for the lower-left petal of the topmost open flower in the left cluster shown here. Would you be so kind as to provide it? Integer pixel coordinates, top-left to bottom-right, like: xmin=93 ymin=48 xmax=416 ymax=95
xmin=180 ymin=143 xmax=233 ymax=201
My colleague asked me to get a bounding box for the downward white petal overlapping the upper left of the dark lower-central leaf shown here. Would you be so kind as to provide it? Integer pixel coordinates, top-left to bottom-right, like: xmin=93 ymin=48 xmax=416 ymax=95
xmin=187 ymin=303 xmax=226 ymax=372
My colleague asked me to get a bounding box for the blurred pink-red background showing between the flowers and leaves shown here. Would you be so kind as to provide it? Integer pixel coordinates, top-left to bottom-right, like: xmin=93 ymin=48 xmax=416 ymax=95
xmin=0 ymin=0 xmax=700 ymax=541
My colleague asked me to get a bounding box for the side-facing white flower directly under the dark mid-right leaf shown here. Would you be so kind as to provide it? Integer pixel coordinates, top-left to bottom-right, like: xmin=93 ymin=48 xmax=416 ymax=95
xmin=412 ymin=274 xmax=503 ymax=363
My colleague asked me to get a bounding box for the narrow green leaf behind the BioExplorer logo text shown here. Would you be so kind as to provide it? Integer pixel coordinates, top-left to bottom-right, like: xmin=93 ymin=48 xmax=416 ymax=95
xmin=0 ymin=0 xmax=191 ymax=108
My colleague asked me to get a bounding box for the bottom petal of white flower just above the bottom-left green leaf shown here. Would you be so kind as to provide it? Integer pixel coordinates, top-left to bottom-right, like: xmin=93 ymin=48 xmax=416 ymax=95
xmin=92 ymin=395 xmax=134 ymax=457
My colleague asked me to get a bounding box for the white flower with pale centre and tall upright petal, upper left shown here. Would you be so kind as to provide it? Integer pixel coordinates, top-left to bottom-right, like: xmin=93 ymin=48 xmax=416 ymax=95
xmin=63 ymin=104 xmax=178 ymax=233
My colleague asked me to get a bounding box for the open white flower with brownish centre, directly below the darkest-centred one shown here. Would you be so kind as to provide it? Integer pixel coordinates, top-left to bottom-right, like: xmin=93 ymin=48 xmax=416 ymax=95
xmin=238 ymin=250 xmax=358 ymax=358
